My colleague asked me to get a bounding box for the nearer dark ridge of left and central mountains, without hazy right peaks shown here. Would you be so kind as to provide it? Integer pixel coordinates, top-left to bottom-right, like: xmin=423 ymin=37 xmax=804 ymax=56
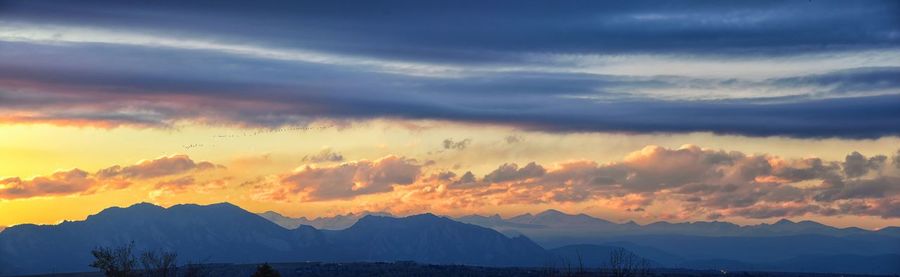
xmin=0 ymin=204 xmax=548 ymax=275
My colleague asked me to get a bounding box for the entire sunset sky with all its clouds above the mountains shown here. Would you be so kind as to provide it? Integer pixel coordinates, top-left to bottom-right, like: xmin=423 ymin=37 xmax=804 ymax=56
xmin=0 ymin=0 xmax=900 ymax=229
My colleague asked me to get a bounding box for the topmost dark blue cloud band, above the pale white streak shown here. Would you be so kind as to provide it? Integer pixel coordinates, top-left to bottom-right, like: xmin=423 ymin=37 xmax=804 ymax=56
xmin=2 ymin=0 xmax=900 ymax=63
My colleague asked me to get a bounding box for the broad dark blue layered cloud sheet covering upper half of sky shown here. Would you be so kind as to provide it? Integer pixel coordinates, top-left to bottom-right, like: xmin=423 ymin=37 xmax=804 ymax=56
xmin=0 ymin=1 xmax=900 ymax=138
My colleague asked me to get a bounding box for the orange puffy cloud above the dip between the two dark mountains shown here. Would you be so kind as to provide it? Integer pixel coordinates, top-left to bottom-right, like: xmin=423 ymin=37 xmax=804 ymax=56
xmin=279 ymin=156 xmax=421 ymax=198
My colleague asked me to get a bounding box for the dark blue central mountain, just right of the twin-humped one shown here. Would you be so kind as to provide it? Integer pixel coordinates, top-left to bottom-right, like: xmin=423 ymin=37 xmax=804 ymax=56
xmin=326 ymin=214 xmax=549 ymax=266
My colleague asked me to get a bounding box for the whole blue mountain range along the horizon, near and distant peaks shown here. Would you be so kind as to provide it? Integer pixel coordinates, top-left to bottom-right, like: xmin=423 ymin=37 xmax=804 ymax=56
xmin=0 ymin=203 xmax=900 ymax=275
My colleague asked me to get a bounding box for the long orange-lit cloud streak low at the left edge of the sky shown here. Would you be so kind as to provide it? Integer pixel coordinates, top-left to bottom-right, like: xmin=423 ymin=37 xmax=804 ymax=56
xmin=0 ymin=155 xmax=221 ymax=200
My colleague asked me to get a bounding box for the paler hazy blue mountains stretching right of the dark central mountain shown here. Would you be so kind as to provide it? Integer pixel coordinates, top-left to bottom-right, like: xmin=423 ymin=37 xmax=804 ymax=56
xmin=260 ymin=209 xmax=900 ymax=273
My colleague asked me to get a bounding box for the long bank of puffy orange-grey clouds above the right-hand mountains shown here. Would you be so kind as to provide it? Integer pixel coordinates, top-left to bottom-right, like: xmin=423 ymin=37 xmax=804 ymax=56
xmin=318 ymin=145 xmax=900 ymax=219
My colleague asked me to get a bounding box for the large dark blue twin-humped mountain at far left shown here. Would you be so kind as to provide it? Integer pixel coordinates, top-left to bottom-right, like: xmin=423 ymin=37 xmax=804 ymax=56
xmin=0 ymin=203 xmax=316 ymax=274
